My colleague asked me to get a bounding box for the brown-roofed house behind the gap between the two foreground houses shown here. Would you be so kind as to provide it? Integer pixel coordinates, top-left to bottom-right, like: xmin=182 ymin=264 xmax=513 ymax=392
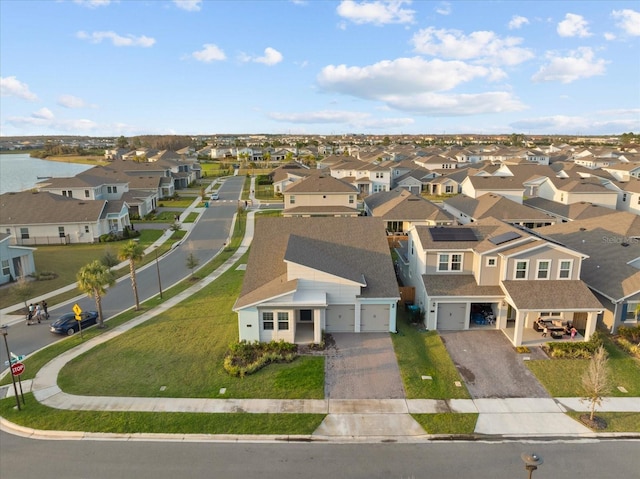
xmin=364 ymin=188 xmax=454 ymax=233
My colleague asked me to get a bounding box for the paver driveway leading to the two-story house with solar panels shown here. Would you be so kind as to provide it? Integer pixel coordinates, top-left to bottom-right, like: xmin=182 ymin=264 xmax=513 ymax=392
xmin=440 ymin=330 xmax=549 ymax=399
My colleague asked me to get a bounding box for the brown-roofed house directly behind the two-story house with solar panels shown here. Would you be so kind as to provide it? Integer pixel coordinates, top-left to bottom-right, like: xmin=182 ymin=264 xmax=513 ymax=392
xmin=443 ymin=193 xmax=556 ymax=228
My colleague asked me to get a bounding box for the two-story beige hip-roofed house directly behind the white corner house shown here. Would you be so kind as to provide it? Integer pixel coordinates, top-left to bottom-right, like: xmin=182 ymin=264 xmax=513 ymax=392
xmin=282 ymin=174 xmax=360 ymax=217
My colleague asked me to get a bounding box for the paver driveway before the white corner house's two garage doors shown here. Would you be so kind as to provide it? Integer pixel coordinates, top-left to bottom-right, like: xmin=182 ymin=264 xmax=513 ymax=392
xmin=325 ymin=333 xmax=405 ymax=399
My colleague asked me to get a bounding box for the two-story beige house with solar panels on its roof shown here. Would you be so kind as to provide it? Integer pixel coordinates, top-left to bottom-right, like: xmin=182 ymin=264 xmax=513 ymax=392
xmin=399 ymin=219 xmax=602 ymax=346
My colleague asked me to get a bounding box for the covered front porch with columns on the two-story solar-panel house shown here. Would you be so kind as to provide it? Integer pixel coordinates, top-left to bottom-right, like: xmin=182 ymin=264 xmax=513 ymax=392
xmin=500 ymin=280 xmax=602 ymax=346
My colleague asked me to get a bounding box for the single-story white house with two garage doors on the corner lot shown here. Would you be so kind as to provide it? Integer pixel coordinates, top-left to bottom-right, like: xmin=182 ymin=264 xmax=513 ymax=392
xmin=233 ymin=217 xmax=400 ymax=343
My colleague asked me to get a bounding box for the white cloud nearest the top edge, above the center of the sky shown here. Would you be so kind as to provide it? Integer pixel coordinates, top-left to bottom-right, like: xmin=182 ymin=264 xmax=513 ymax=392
xmin=336 ymin=0 xmax=415 ymax=25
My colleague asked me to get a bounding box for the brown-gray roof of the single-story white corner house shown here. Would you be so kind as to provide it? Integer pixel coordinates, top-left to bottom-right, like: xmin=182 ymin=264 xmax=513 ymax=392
xmin=235 ymin=217 xmax=399 ymax=309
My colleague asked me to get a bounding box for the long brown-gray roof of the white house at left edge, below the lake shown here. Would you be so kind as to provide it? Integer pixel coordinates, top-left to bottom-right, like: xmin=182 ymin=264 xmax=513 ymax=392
xmin=0 ymin=191 xmax=105 ymax=225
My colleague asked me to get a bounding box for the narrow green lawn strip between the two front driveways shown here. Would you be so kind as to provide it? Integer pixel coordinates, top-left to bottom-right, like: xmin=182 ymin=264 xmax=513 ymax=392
xmin=392 ymin=311 xmax=470 ymax=399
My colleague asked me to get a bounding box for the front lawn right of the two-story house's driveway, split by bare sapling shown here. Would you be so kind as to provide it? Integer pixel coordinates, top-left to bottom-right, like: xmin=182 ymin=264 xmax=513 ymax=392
xmin=527 ymin=338 xmax=640 ymax=397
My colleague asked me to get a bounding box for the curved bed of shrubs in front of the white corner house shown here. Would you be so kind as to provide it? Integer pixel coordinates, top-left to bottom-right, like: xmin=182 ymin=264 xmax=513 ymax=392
xmin=224 ymin=341 xmax=298 ymax=377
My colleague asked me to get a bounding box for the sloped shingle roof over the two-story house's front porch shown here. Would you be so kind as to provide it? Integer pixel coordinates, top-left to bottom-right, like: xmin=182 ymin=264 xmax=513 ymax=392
xmin=502 ymin=280 xmax=602 ymax=311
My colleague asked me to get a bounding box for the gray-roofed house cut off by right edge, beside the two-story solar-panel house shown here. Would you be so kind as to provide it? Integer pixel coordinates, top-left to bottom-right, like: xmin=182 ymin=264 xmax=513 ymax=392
xmin=536 ymin=214 xmax=640 ymax=333
